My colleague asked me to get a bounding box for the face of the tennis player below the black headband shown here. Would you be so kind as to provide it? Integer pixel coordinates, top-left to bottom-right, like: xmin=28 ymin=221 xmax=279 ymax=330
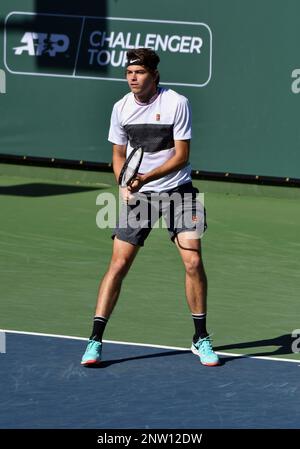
xmin=126 ymin=65 xmax=156 ymax=100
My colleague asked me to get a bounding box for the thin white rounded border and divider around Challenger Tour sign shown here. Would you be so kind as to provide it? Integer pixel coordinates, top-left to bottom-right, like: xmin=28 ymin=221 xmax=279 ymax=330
xmin=3 ymin=11 xmax=212 ymax=87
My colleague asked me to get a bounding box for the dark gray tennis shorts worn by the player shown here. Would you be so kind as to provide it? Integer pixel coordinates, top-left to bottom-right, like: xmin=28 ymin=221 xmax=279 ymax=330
xmin=112 ymin=182 xmax=207 ymax=246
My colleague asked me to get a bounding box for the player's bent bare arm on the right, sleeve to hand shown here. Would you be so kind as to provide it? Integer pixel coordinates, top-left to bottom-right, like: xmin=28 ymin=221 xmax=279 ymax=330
xmin=129 ymin=140 xmax=190 ymax=192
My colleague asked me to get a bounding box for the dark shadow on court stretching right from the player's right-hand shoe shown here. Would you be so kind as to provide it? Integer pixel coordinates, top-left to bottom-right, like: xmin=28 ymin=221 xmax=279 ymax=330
xmin=215 ymin=334 xmax=295 ymax=357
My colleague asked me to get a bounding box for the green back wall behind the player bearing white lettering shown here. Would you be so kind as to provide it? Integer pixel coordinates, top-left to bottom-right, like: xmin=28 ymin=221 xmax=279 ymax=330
xmin=0 ymin=0 xmax=300 ymax=178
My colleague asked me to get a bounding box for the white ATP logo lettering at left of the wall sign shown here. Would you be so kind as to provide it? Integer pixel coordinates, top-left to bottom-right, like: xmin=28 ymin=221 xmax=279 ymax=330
xmin=13 ymin=32 xmax=70 ymax=57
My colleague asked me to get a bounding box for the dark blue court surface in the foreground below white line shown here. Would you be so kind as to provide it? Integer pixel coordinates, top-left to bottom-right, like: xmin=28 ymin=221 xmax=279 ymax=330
xmin=0 ymin=334 xmax=300 ymax=429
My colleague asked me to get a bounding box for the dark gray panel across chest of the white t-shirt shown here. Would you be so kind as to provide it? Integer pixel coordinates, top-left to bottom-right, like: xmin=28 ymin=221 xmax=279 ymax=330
xmin=124 ymin=124 xmax=174 ymax=153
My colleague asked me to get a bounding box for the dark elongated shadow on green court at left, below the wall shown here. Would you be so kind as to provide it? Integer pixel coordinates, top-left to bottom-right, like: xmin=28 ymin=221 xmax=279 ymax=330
xmin=0 ymin=183 xmax=103 ymax=197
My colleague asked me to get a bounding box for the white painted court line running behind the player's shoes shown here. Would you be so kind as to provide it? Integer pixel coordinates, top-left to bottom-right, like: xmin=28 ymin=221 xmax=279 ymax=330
xmin=0 ymin=329 xmax=300 ymax=366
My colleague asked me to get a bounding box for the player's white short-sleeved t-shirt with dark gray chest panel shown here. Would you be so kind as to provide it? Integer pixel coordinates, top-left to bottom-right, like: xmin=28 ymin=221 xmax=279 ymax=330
xmin=108 ymin=88 xmax=192 ymax=192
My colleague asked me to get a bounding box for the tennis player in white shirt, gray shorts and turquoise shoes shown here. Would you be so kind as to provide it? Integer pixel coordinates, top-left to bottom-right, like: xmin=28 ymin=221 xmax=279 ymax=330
xmin=81 ymin=48 xmax=220 ymax=366
